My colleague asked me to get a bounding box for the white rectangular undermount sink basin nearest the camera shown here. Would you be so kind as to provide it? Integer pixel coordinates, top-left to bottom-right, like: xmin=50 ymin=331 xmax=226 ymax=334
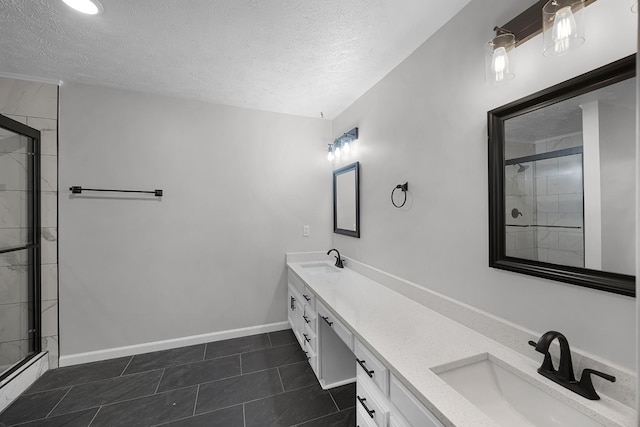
xmin=433 ymin=354 xmax=603 ymax=427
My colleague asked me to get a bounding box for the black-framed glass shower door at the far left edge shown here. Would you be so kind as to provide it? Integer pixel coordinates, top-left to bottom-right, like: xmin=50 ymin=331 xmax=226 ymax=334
xmin=0 ymin=115 xmax=41 ymax=380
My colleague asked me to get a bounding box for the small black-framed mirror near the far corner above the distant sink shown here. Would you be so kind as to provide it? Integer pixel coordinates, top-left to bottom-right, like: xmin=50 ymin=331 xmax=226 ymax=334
xmin=333 ymin=162 xmax=360 ymax=237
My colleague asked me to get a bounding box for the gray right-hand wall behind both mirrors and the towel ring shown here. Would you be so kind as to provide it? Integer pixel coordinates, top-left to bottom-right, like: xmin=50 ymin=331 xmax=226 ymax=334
xmin=333 ymin=0 xmax=637 ymax=370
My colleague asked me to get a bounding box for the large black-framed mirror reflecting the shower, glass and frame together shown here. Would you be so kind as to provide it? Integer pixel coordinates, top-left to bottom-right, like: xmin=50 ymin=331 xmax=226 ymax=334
xmin=488 ymin=55 xmax=637 ymax=296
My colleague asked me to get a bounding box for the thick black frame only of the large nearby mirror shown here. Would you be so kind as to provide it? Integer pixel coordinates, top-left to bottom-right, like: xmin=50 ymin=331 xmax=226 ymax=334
xmin=487 ymin=54 xmax=636 ymax=297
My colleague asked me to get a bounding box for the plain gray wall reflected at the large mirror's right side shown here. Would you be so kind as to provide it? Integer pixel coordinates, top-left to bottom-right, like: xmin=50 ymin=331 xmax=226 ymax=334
xmin=600 ymin=103 xmax=636 ymax=275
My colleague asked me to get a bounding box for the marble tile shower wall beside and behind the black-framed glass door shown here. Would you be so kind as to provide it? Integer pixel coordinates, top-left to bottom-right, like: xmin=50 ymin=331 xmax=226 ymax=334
xmin=0 ymin=77 xmax=59 ymax=368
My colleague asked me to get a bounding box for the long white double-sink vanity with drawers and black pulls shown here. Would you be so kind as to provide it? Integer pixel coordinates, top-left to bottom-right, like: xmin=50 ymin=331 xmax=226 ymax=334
xmin=287 ymin=254 xmax=636 ymax=427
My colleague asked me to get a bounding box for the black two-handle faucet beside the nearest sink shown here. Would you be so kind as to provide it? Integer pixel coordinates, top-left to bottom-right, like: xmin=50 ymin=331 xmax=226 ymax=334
xmin=529 ymin=331 xmax=616 ymax=400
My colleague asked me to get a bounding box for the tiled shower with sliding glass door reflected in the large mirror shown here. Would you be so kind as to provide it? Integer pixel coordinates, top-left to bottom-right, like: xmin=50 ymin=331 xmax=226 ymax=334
xmin=505 ymin=139 xmax=585 ymax=267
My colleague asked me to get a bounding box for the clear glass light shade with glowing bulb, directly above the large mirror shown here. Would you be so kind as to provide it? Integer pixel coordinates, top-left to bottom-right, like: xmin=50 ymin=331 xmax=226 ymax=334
xmin=542 ymin=0 xmax=585 ymax=56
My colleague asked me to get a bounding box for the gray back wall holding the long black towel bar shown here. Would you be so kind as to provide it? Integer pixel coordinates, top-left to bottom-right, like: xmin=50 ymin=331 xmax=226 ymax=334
xmin=60 ymin=84 xmax=331 ymax=356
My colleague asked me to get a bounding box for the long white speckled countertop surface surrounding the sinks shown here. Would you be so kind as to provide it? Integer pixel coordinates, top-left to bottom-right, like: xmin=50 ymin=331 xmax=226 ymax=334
xmin=287 ymin=261 xmax=636 ymax=427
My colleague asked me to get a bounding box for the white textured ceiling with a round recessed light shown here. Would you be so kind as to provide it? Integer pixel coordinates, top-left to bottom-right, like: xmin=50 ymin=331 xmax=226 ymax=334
xmin=0 ymin=0 xmax=469 ymax=118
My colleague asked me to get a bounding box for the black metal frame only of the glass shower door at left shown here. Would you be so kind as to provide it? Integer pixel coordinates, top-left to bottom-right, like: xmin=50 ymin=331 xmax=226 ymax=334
xmin=0 ymin=114 xmax=42 ymax=381
